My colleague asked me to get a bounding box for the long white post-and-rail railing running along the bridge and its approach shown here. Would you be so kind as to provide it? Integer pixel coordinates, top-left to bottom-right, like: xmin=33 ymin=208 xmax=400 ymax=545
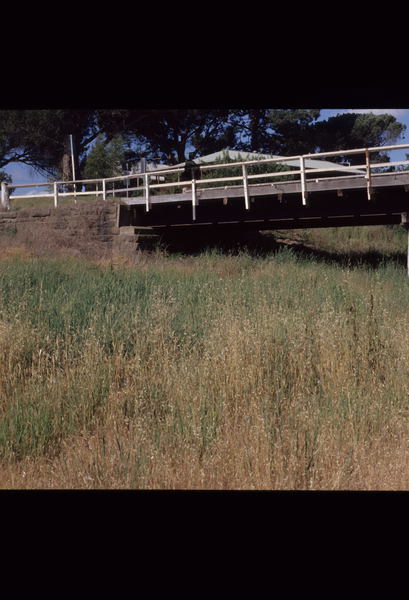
xmin=1 ymin=144 xmax=409 ymax=220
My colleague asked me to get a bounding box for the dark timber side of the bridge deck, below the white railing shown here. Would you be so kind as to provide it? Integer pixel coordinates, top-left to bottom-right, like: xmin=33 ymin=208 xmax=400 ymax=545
xmin=119 ymin=173 xmax=409 ymax=234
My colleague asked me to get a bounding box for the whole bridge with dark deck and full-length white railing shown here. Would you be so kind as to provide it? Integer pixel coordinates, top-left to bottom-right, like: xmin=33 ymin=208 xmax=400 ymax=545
xmin=1 ymin=144 xmax=409 ymax=264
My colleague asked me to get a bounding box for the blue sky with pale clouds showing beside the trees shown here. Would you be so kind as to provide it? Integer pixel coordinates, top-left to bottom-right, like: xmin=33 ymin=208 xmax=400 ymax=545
xmin=3 ymin=108 xmax=409 ymax=194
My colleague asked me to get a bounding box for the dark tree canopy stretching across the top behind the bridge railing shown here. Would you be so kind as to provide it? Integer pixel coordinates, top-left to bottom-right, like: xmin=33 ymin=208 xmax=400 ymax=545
xmin=0 ymin=108 xmax=406 ymax=179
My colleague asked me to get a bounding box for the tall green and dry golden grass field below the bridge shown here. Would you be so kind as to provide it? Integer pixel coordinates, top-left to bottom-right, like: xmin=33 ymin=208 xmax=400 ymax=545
xmin=0 ymin=227 xmax=409 ymax=490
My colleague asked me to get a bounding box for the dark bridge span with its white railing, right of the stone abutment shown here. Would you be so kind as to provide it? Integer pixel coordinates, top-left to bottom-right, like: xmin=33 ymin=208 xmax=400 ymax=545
xmin=115 ymin=145 xmax=409 ymax=230
